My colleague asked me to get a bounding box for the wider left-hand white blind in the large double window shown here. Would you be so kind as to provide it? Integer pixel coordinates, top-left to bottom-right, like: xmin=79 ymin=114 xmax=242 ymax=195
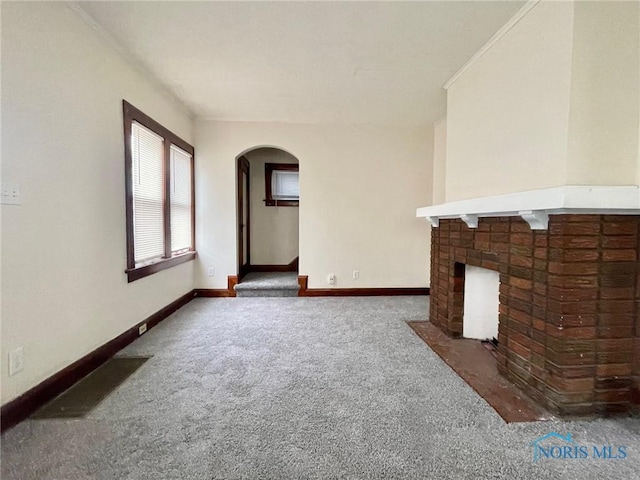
xmin=131 ymin=122 xmax=164 ymax=265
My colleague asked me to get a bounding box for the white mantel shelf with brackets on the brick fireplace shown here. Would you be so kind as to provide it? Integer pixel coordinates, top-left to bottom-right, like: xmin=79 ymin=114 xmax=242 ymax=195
xmin=416 ymin=186 xmax=640 ymax=230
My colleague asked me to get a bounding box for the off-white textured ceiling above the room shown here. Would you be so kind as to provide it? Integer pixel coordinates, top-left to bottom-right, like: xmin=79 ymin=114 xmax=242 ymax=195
xmin=77 ymin=1 xmax=523 ymax=126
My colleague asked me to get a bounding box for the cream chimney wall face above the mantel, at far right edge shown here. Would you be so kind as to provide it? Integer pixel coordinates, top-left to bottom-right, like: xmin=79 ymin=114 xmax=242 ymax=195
xmin=566 ymin=2 xmax=640 ymax=185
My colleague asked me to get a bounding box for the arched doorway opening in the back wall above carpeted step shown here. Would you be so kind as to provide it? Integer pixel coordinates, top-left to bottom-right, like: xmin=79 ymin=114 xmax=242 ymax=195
xmin=237 ymin=146 xmax=300 ymax=281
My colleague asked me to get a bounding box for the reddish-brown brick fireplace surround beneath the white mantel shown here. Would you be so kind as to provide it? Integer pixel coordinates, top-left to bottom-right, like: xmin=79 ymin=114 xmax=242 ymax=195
xmin=430 ymin=215 xmax=640 ymax=414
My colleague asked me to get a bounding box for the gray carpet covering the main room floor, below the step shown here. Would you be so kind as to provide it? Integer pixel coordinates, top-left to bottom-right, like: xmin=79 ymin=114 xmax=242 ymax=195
xmin=2 ymin=297 xmax=640 ymax=480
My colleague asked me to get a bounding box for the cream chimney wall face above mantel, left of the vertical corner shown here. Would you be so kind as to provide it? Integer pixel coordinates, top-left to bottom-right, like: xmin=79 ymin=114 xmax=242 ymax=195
xmin=446 ymin=2 xmax=573 ymax=201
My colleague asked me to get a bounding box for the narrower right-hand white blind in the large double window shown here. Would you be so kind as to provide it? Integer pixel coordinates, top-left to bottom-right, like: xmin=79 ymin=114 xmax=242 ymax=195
xmin=170 ymin=145 xmax=192 ymax=253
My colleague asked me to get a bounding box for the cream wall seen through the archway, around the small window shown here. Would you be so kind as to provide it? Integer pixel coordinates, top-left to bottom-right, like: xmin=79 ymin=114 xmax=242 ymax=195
xmin=245 ymin=148 xmax=298 ymax=265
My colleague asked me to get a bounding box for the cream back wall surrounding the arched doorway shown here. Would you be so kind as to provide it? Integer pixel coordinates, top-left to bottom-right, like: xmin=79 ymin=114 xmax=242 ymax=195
xmin=196 ymin=121 xmax=433 ymax=288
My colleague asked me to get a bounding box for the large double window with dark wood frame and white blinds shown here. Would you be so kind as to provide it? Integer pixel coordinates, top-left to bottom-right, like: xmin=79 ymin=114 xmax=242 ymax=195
xmin=122 ymin=100 xmax=195 ymax=282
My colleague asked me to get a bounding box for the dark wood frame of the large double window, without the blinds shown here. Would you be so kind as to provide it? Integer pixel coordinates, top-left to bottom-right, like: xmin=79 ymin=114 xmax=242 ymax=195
xmin=122 ymin=100 xmax=196 ymax=282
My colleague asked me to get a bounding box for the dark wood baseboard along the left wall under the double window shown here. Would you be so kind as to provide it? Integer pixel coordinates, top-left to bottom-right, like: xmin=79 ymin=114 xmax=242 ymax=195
xmin=0 ymin=290 xmax=195 ymax=432
